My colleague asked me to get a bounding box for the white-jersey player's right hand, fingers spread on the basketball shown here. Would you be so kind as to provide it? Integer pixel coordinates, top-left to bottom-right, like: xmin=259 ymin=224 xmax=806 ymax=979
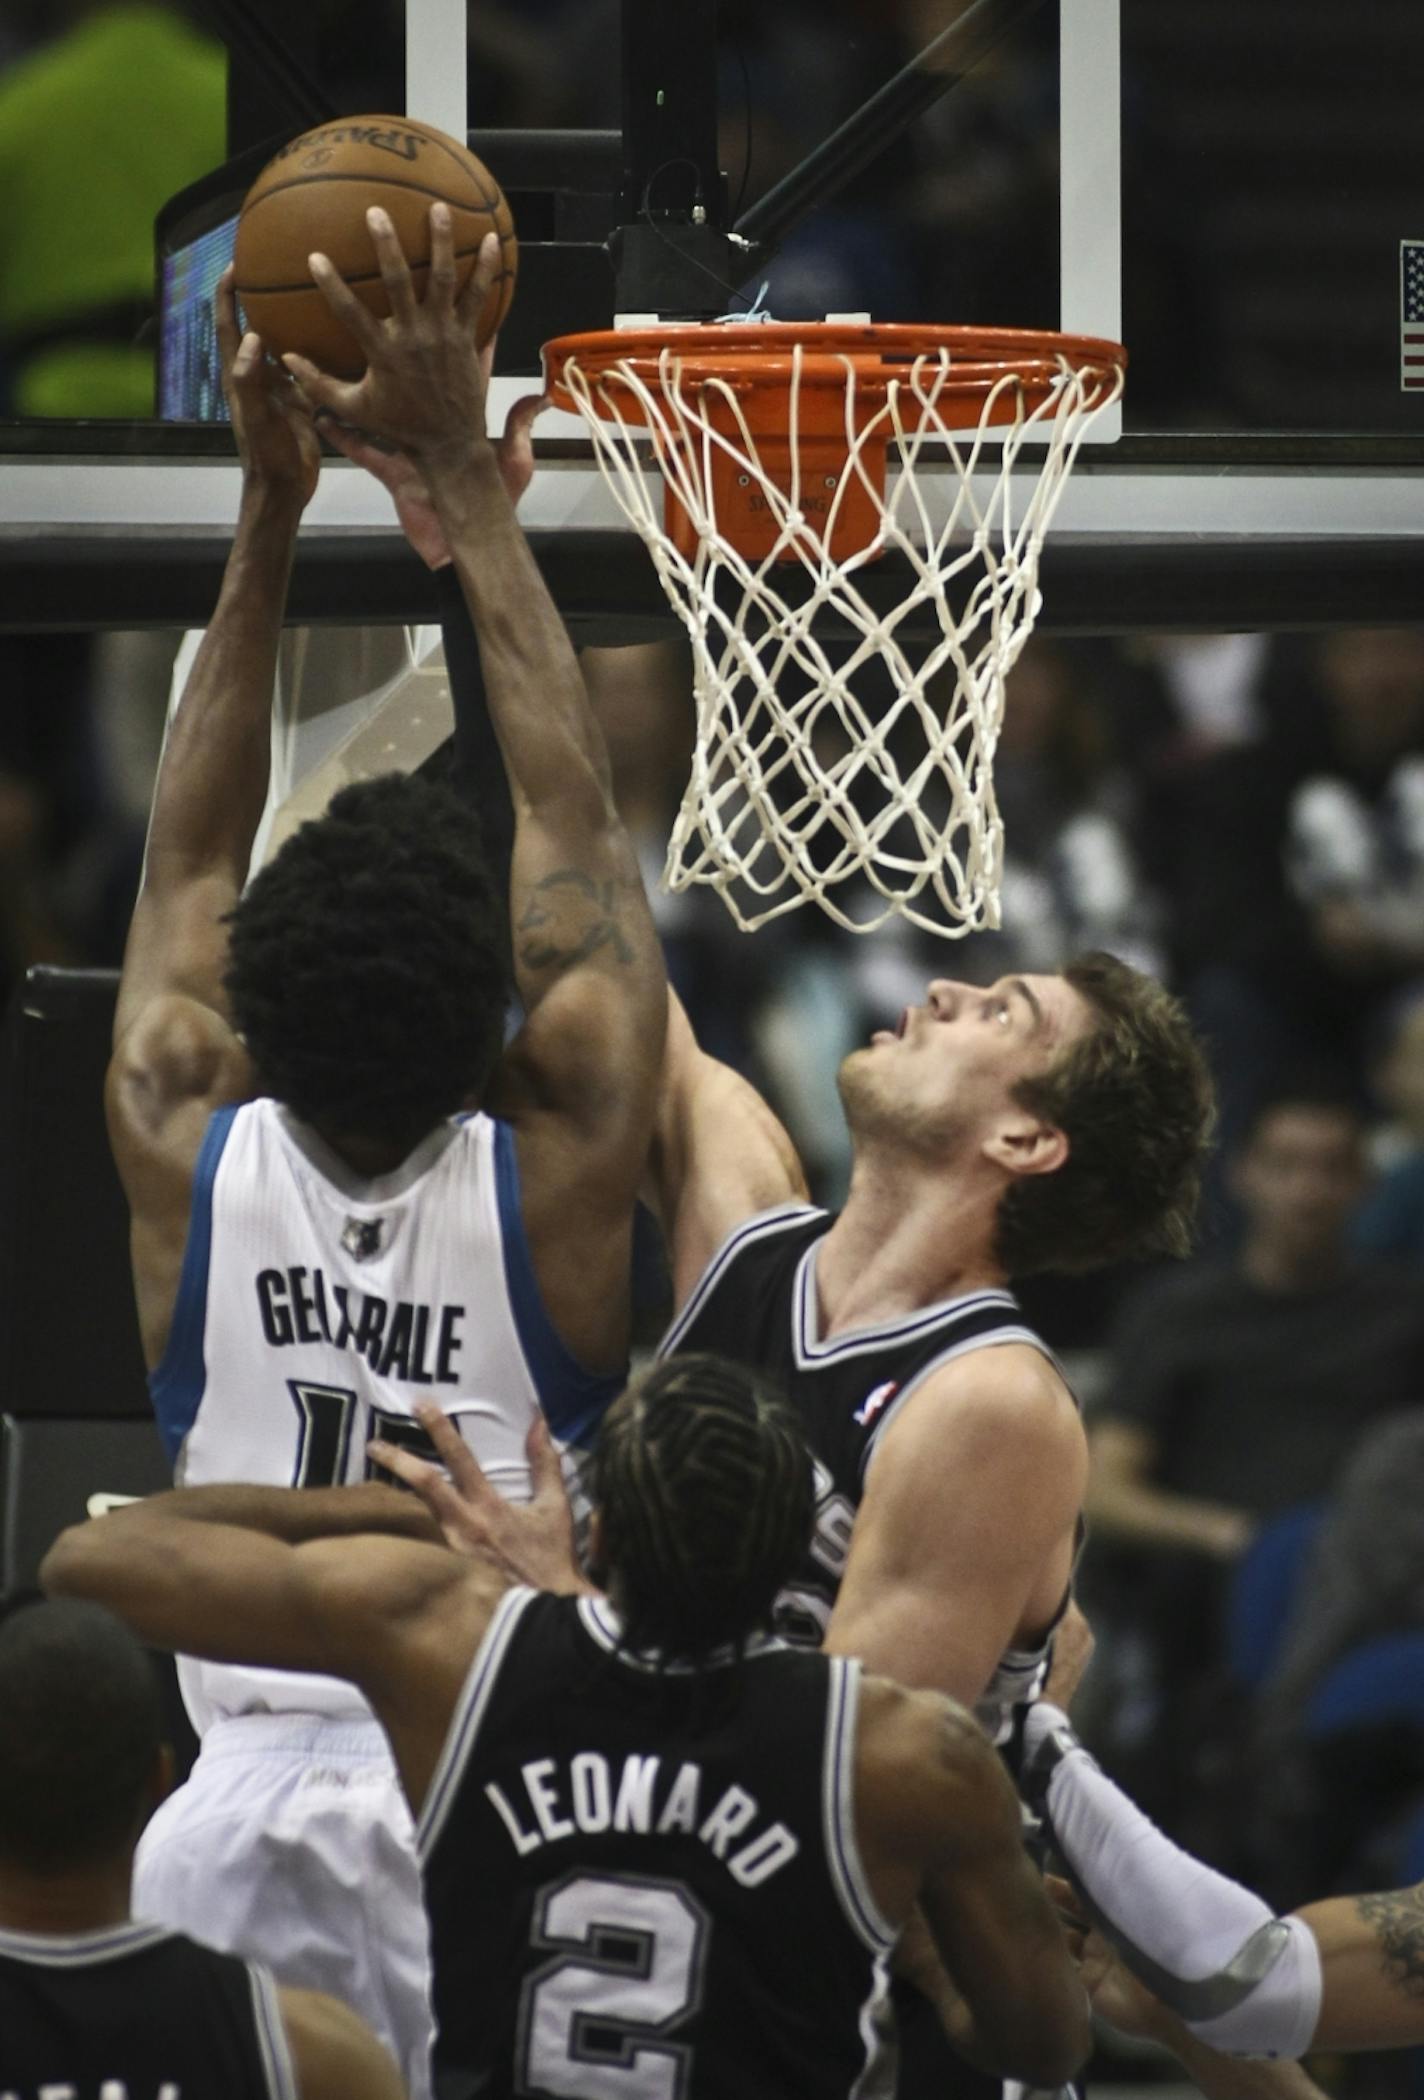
xmin=284 ymin=204 xmax=500 ymax=460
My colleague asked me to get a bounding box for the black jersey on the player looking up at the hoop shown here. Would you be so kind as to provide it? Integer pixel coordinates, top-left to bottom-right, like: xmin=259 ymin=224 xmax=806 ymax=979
xmin=659 ymin=1203 xmax=1054 ymax=1741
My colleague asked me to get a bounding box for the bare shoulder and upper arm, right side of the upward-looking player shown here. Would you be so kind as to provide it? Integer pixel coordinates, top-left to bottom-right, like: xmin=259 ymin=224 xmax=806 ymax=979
xmin=825 ymin=1344 xmax=1086 ymax=1707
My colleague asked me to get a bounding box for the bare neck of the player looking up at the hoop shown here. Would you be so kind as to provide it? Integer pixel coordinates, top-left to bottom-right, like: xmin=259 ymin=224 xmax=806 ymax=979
xmin=817 ymin=1157 xmax=1006 ymax=1334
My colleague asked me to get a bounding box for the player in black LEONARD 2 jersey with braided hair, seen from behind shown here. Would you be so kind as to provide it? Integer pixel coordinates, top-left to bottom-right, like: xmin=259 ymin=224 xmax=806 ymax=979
xmin=44 ymin=1357 xmax=1088 ymax=2100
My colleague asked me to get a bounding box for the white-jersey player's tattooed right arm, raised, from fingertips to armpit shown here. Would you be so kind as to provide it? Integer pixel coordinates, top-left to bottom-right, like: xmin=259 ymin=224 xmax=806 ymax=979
xmin=288 ymin=206 xmax=666 ymax=1369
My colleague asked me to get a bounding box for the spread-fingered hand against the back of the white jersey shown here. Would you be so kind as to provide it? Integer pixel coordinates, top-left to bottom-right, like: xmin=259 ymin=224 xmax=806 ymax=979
xmin=368 ymin=1401 xmax=592 ymax=1596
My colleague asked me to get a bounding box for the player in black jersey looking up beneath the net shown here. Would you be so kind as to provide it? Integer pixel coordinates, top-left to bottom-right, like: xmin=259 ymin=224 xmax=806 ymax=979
xmin=395 ymin=956 xmax=1212 ymax=2100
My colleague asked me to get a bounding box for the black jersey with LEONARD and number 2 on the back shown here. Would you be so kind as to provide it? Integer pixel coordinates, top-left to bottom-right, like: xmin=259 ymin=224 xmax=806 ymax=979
xmin=420 ymin=1590 xmax=893 ymax=2100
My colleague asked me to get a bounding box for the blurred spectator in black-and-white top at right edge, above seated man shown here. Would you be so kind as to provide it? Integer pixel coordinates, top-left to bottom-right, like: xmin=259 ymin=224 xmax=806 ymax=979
xmin=1147 ymin=628 xmax=1424 ymax=1184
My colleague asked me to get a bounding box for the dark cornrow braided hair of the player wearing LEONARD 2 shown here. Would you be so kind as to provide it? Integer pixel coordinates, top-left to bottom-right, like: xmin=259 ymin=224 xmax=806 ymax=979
xmin=588 ymin=1355 xmax=815 ymax=1663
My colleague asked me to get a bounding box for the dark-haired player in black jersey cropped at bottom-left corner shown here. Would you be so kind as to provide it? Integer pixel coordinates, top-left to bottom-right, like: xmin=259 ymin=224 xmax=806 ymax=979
xmin=0 ymin=1602 xmax=405 ymax=2100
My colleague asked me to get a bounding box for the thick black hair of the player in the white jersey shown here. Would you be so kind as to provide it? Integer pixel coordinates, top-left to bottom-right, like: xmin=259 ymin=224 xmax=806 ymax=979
xmin=225 ymin=773 xmax=508 ymax=1145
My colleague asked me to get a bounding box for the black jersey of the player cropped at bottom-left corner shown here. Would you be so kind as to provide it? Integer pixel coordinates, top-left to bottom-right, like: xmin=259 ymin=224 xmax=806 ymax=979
xmin=0 ymin=1924 xmax=296 ymax=2100
